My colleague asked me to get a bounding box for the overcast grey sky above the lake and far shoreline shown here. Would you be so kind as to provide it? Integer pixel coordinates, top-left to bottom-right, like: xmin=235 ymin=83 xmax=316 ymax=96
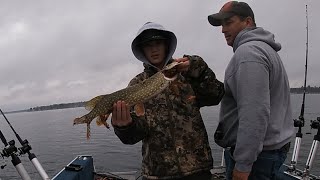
xmin=0 ymin=0 xmax=320 ymax=111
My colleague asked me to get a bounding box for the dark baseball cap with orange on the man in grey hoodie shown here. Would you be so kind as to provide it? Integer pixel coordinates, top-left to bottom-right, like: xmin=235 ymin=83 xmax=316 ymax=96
xmin=208 ymin=1 xmax=254 ymax=26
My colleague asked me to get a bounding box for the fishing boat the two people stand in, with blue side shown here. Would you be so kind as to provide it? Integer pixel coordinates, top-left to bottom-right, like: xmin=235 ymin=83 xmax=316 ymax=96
xmin=52 ymin=141 xmax=320 ymax=180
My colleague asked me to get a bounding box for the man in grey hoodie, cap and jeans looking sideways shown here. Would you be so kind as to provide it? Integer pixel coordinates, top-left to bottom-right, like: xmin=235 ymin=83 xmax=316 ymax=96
xmin=208 ymin=1 xmax=294 ymax=180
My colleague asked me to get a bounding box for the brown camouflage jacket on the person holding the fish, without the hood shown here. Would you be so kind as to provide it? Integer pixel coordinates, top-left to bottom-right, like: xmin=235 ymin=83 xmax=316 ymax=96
xmin=114 ymin=56 xmax=224 ymax=179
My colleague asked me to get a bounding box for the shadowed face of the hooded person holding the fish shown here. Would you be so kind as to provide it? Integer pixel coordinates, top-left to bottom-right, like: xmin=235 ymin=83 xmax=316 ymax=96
xmin=142 ymin=40 xmax=167 ymax=69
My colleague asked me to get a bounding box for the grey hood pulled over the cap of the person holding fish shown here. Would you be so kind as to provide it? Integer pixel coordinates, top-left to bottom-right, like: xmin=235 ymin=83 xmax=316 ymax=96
xmin=131 ymin=22 xmax=177 ymax=68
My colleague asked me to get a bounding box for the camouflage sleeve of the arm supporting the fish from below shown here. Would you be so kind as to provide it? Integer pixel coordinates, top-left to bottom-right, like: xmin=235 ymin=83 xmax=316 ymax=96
xmin=114 ymin=74 xmax=147 ymax=144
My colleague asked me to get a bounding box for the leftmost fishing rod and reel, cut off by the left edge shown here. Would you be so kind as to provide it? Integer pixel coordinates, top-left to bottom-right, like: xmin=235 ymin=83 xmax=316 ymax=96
xmin=0 ymin=126 xmax=31 ymax=180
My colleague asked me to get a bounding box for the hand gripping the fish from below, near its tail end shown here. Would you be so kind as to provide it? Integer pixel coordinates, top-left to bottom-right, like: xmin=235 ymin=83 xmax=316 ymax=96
xmin=111 ymin=101 xmax=132 ymax=127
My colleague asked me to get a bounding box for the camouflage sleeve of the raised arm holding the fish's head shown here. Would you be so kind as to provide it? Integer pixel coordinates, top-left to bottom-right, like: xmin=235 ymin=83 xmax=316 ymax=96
xmin=183 ymin=55 xmax=224 ymax=107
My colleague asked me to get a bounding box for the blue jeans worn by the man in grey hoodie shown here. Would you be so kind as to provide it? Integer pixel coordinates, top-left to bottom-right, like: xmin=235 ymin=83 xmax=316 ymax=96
xmin=224 ymin=147 xmax=288 ymax=180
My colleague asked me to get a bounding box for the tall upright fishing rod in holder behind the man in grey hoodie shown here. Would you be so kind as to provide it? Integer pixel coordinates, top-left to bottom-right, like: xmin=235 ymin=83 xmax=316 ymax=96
xmin=289 ymin=5 xmax=309 ymax=172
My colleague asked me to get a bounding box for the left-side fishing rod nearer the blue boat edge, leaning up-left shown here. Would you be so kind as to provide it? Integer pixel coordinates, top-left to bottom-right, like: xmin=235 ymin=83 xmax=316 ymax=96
xmin=0 ymin=109 xmax=49 ymax=180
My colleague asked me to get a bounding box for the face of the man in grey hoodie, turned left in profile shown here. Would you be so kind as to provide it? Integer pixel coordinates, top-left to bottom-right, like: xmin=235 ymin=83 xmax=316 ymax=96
xmin=222 ymin=16 xmax=249 ymax=46
